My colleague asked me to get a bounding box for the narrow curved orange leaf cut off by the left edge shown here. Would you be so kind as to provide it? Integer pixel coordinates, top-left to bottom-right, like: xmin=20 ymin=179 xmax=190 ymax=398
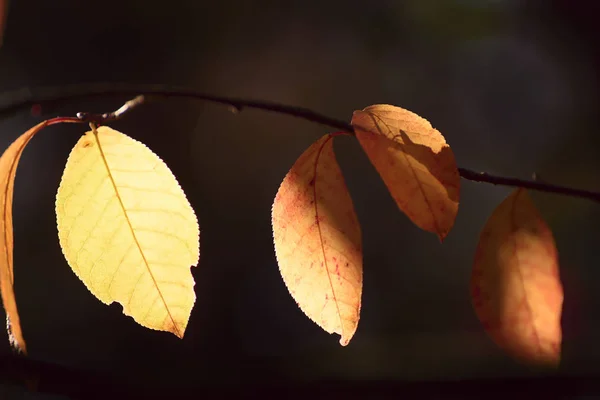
xmin=0 ymin=118 xmax=73 ymax=353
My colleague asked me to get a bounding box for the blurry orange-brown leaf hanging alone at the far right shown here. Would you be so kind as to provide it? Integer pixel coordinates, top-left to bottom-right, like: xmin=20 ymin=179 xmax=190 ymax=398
xmin=471 ymin=189 xmax=563 ymax=366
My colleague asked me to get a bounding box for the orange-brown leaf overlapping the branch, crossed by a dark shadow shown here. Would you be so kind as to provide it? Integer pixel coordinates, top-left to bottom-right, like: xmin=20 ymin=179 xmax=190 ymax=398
xmin=352 ymin=104 xmax=460 ymax=240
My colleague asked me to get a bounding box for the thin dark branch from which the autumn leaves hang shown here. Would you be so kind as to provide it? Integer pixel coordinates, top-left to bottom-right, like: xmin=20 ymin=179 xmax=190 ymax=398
xmin=0 ymin=83 xmax=600 ymax=203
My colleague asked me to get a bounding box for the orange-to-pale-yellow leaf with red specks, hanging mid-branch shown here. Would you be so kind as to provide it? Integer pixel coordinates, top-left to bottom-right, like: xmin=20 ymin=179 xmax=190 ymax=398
xmin=272 ymin=135 xmax=362 ymax=346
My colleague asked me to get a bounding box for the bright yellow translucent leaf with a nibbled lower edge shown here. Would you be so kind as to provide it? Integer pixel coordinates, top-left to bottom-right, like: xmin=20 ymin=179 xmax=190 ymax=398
xmin=56 ymin=127 xmax=200 ymax=338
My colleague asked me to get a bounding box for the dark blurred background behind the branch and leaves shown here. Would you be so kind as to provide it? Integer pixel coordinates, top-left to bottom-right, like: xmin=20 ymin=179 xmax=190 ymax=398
xmin=0 ymin=0 xmax=600 ymax=398
